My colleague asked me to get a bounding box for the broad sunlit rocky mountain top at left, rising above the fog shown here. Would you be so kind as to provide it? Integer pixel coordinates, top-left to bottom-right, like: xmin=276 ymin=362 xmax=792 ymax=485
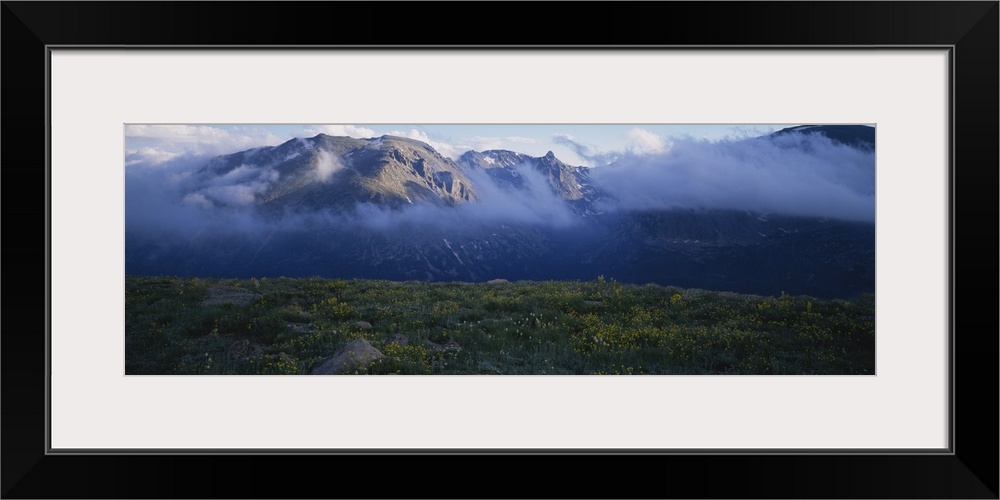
xmin=193 ymin=134 xmax=476 ymax=213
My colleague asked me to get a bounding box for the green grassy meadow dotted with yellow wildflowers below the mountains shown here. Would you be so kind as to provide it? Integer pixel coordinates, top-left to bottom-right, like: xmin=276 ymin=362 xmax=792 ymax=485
xmin=125 ymin=276 xmax=875 ymax=375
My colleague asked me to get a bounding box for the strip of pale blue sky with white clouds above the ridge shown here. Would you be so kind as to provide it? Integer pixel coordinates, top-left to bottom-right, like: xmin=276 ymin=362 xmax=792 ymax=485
xmin=125 ymin=124 xmax=795 ymax=166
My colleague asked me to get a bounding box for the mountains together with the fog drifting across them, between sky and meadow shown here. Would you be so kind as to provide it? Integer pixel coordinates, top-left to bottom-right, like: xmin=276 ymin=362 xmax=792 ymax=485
xmin=125 ymin=126 xmax=875 ymax=297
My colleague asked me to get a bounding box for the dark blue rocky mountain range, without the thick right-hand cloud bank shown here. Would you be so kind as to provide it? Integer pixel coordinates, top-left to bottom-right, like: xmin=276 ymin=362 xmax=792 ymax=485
xmin=125 ymin=125 xmax=875 ymax=298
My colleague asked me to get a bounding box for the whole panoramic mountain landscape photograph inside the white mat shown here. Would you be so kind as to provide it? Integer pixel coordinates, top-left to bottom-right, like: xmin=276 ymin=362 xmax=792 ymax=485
xmin=123 ymin=124 xmax=876 ymax=376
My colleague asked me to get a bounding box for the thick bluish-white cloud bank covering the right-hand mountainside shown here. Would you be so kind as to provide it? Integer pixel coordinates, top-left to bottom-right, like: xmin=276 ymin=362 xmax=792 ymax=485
xmin=591 ymin=134 xmax=875 ymax=221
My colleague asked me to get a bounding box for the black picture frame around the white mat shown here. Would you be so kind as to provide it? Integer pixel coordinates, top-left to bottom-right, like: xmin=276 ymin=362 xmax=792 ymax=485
xmin=0 ymin=1 xmax=1000 ymax=498
